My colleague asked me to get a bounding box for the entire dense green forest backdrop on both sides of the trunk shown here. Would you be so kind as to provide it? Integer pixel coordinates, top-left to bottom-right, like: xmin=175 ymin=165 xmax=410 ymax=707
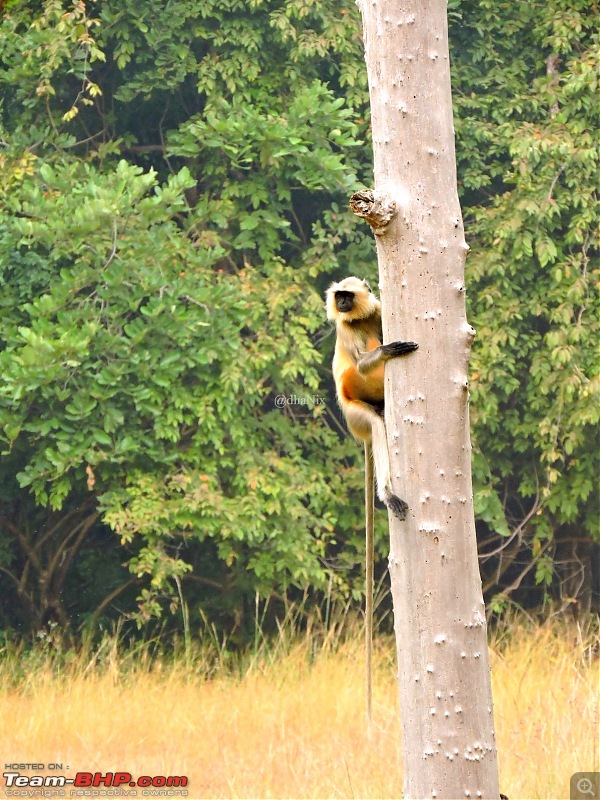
xmin=0 ymin=0 xmax=600 ymax=645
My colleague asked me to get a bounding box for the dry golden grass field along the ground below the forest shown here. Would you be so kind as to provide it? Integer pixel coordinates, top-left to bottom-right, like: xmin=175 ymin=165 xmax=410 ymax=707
xmin=0 ymin=622 xmax=600 ymax=800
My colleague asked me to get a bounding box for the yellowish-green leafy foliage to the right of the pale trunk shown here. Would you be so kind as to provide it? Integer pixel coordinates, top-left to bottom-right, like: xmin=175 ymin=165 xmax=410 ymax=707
xmin=457 ymin=2 xmax=600 ymax=585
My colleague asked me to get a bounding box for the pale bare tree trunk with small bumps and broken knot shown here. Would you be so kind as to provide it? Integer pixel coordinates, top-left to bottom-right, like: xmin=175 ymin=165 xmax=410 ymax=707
xmin=353 ymin=0 xmax=499 ymax=800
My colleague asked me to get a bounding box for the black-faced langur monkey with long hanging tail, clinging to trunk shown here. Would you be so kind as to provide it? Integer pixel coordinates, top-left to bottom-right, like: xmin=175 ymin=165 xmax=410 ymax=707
xmin=326 ymin=277 xmax=418 ymax=723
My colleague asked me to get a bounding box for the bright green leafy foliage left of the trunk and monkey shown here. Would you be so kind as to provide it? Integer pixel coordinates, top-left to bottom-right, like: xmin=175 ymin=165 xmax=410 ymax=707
xmin=0 ymin=0 xmax=376 ymax=632
